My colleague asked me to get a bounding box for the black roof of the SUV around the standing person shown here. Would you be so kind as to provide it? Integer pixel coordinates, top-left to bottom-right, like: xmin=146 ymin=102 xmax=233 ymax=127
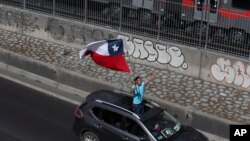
xmin=86 ymin=90 xmax=163 ymax=121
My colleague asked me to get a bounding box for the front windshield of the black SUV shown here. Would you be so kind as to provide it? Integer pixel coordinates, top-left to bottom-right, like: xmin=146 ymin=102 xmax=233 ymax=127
xmin=144 ymin=111 xmax=181 ymax=141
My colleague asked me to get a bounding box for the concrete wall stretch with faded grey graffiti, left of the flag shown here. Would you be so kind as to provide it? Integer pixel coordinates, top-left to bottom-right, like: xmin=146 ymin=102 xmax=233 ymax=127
xmin=0 ymin=5 xmax=117 ymax=48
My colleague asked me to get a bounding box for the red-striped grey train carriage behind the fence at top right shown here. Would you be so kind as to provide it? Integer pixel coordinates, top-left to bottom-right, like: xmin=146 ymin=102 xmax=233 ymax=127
xmin=180 ymin=0 xmax=250 ymax=44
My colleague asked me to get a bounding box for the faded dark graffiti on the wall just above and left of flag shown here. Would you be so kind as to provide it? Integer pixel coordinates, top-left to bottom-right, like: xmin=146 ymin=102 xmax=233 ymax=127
xmin=46 ymin=18 xmax=114 ymax=44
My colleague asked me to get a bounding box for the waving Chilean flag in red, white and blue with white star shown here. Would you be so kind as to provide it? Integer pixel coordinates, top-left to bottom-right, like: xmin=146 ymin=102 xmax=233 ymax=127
xmin=79 ymin=39 xmax=130 ymax=72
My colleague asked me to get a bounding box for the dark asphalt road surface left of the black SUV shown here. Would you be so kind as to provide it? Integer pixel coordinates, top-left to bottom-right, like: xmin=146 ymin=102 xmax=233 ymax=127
xmin=0 ymin=77 xmax=77 ymax=141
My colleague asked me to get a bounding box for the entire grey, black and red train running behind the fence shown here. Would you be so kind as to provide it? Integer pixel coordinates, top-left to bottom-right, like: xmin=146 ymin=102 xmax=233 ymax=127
xmin=1 ymin=0 xmax=250 ymax=44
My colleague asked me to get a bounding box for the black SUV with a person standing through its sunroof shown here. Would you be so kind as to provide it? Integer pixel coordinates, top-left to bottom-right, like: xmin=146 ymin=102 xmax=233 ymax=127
xmin=73 ymin=90 xmax=208 ymax=141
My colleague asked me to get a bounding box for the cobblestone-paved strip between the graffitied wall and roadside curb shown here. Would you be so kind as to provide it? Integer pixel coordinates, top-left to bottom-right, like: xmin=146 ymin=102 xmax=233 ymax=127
xmin=0 ymin=29 xmax=250 ymax=124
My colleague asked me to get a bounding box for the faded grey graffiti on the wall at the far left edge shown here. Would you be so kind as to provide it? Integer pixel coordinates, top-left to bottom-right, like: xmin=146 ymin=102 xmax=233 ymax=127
xmin=0 ymin=8 xmax=40 ymax=32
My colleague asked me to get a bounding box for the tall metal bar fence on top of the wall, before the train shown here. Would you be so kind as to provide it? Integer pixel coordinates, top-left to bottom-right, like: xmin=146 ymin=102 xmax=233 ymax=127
xmin=0 ymin=0 xmax=250 ymax=58
